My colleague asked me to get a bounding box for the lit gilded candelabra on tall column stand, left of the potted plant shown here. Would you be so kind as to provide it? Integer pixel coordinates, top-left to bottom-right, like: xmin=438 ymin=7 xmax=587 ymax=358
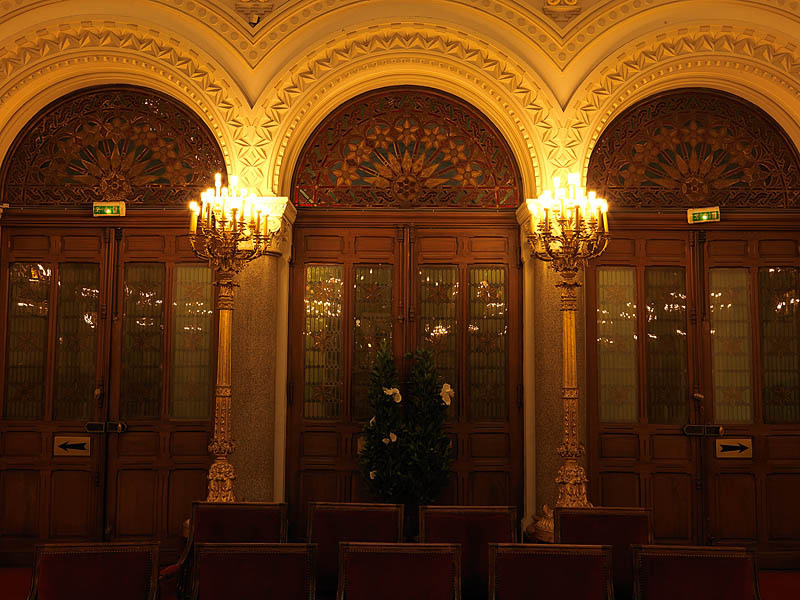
xmin=189 ymin=173 xmax=288 ymax=502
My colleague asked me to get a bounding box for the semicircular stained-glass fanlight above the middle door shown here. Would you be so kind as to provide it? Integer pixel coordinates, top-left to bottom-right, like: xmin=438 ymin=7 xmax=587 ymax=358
xmin=292 ymin=87 xmax=522 ymax=210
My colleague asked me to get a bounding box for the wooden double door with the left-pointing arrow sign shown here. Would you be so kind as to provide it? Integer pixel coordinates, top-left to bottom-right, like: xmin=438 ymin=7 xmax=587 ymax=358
xmin=0 ymin=219 xmax=215 ymax=560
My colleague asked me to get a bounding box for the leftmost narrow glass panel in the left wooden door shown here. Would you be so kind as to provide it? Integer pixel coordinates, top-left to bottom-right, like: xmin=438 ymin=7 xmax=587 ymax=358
xmin=3 ymin=262 xmax=51 ymax=420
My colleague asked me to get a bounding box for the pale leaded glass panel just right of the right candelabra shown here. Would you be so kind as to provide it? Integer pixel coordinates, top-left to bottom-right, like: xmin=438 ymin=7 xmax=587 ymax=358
xmin=597 ymin=267 xmax=639 ymax=423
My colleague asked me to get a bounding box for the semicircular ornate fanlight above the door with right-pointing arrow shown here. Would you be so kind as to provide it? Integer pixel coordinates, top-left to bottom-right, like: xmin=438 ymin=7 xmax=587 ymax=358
xmin=587 ymin=89 xmax=800 ymax=209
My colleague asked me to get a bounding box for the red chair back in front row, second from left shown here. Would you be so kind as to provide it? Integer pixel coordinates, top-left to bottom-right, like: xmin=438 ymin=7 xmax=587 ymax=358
xmin=192 ymin=544 xmax=316 ymax=600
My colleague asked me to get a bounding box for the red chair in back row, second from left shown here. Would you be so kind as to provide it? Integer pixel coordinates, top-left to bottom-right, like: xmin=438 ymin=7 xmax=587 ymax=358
xmin=306 ymin=502 xmax=403 ymax=598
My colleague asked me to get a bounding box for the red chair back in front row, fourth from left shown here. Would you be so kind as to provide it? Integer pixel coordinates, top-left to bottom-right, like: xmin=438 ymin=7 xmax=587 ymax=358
xmin=489 ymin=544 xmax=612 ymax=600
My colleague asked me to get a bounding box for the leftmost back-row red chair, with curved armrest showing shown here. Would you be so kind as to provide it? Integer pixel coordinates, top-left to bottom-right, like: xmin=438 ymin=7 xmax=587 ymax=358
xmin=159 ymin=502 xmax=287 ymax=598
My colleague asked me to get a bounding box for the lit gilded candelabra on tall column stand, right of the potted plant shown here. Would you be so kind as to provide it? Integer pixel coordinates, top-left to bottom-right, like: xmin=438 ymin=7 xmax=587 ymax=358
xmin=528 ymin=173 xmax=608 ymax=539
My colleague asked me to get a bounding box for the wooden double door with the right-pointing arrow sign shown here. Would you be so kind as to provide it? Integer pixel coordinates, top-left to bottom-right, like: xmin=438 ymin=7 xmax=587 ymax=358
xmin=587 ymin=223 xmax=800 ymax=567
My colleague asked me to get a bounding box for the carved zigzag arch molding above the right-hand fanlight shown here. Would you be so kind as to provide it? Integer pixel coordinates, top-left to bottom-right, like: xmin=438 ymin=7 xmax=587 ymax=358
xmin=562 ymin=28 xmax=800 ymax=172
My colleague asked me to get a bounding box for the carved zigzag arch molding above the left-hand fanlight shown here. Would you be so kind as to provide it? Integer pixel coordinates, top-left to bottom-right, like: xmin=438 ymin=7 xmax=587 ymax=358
xmin=0 ymin=22 xmax=252 ymax=185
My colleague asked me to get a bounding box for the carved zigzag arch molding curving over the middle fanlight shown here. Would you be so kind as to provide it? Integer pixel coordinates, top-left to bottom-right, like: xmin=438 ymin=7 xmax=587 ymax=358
xmin=253 ymin=29 xmax=554 ymax=189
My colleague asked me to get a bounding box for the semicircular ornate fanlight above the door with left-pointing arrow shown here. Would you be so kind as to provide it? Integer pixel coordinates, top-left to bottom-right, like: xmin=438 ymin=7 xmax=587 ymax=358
xmin=0 ymin=86 xmax=225 ymax=208
